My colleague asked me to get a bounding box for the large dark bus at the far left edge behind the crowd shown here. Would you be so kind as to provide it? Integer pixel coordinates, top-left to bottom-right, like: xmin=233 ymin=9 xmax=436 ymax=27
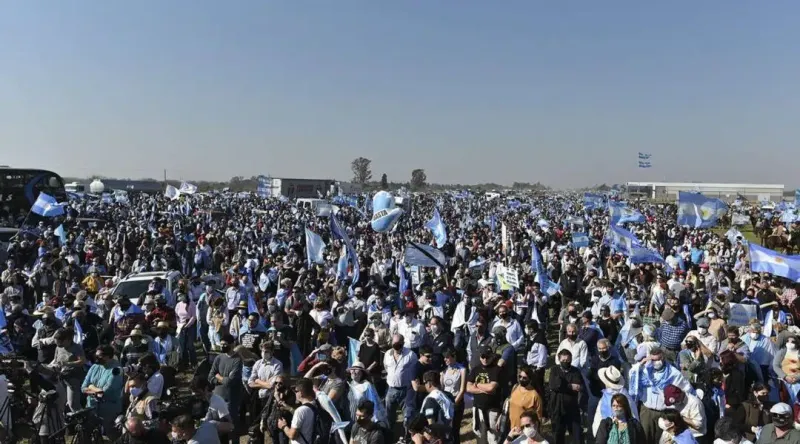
xmin=0 ymin=167 xmax=67 ymax=226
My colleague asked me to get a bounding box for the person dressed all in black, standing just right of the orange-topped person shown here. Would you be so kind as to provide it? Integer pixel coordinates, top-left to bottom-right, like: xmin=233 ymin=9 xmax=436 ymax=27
xmin=547 ymin=350 xmax=585 ymax=444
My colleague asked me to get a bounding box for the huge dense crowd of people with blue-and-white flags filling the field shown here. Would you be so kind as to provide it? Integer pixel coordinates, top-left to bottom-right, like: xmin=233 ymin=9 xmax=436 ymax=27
xmin=0 ymin=192 xmax=800 ymax=444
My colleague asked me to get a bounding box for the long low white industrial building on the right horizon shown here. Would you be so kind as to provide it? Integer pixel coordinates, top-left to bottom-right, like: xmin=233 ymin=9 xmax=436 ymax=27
xmin=626 ymin=182 xmax=784 ymax=202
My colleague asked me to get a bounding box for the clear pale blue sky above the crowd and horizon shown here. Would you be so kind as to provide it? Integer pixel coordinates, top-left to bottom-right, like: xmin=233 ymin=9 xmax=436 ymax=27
xmin=0 ymin=0 xmax=800 ymax=187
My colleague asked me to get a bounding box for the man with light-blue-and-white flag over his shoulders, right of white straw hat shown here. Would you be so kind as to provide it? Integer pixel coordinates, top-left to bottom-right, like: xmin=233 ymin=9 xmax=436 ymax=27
xmin=628 ymin=347 xmax=694 ymax=442
